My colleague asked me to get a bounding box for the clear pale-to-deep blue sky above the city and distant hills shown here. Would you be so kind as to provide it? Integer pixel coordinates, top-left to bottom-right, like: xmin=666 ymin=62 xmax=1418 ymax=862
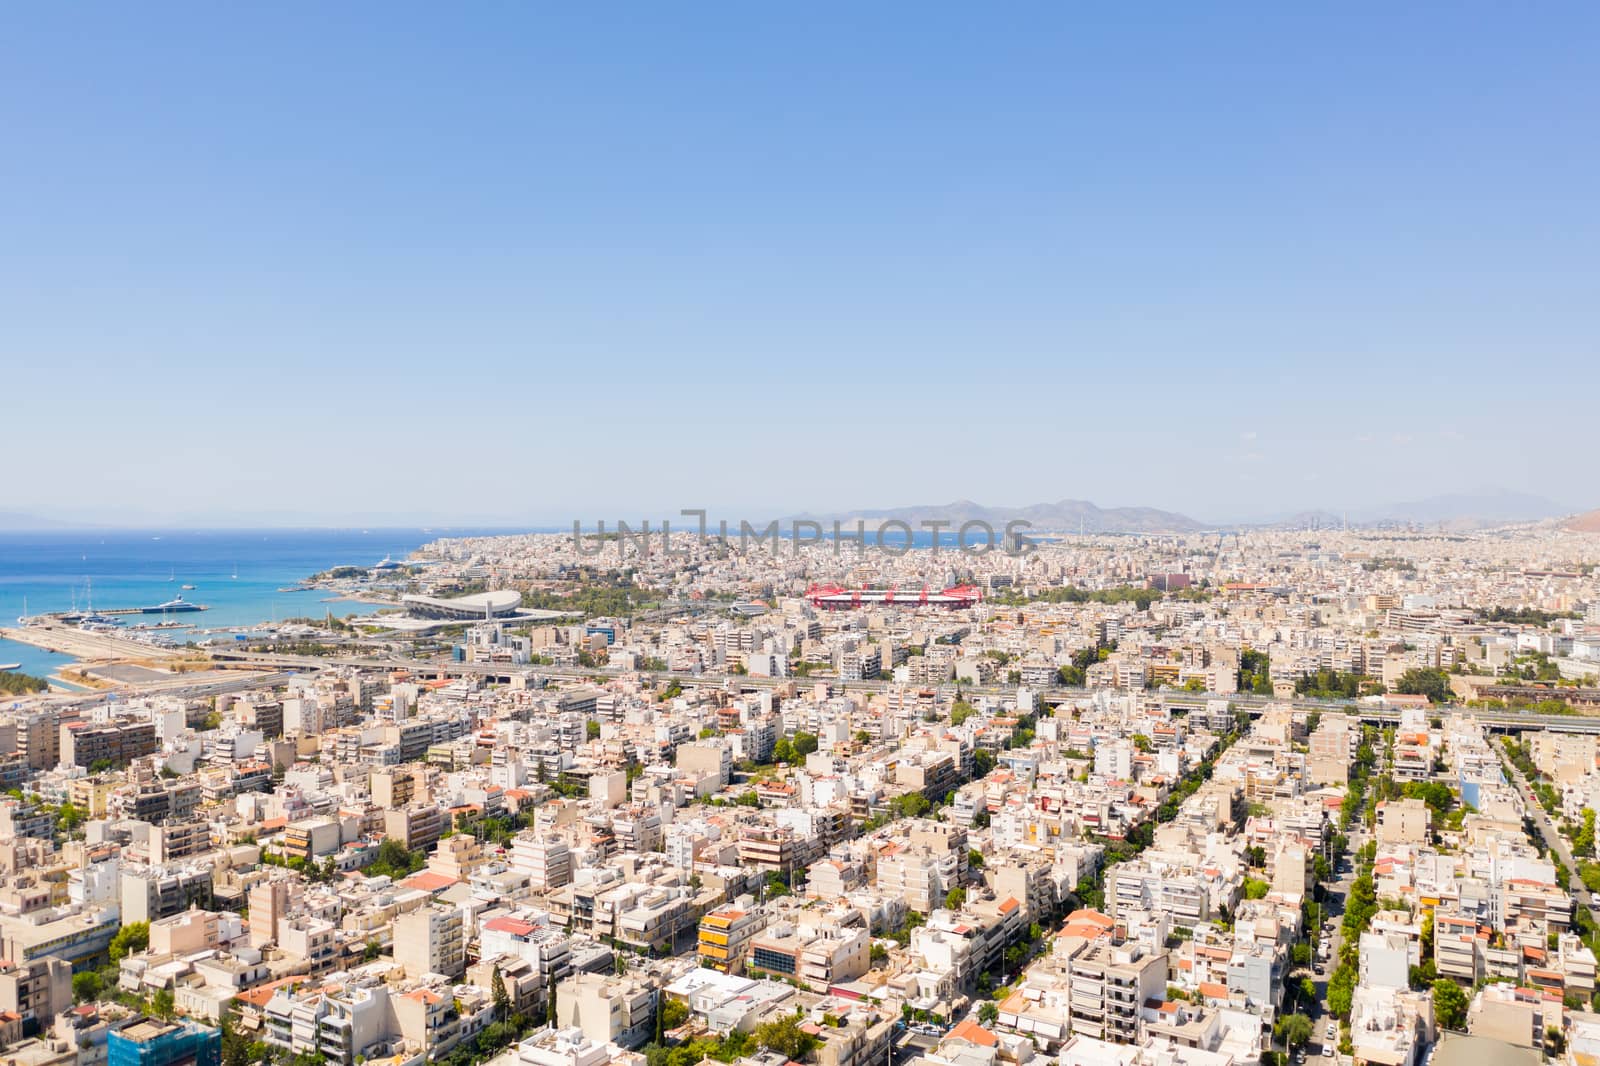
xmin=0 ymin=2 xmax=1600 ymax=523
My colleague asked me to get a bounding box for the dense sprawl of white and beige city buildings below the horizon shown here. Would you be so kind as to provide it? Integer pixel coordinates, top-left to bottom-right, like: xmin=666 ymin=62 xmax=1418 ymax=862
xmin=0 ymin=523 xmax=1600 ymax=1066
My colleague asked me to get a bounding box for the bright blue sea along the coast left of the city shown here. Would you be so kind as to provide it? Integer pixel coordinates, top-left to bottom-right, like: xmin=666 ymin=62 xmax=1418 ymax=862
xmin=0 ymin=528 xmax=521 ymax=677
